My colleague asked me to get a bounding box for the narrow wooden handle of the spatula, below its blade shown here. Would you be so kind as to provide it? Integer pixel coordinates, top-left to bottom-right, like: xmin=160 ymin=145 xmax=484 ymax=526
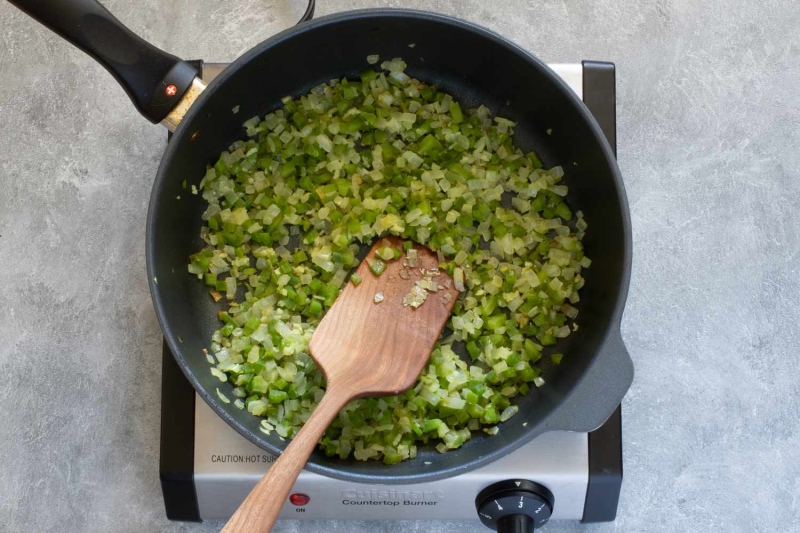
xmin=222 ymin=388 xmax=351 ymax=533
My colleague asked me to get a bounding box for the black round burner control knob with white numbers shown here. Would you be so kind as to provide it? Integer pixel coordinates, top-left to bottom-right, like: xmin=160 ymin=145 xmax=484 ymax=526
xmin=475 ymin=479 xmax=555 ymax=533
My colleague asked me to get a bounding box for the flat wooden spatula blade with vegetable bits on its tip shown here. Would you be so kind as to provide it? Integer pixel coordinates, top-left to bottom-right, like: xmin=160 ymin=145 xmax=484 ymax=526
xmin=309 ymin=237 xmax=458 ymax=396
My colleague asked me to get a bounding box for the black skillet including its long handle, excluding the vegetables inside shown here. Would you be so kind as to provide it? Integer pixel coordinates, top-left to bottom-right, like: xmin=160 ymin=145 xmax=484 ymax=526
xmin=4 ymin=0 xmax=633 ymax=483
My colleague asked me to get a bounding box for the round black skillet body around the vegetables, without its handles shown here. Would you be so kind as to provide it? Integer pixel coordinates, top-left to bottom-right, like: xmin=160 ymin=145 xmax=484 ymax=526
xmin=148 ymin=10 xmax=627 ymax=483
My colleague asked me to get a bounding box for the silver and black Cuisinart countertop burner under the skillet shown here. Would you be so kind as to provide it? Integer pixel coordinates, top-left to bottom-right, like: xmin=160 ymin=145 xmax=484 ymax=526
xmin=160 ymin=61 xmax=622 ymax=531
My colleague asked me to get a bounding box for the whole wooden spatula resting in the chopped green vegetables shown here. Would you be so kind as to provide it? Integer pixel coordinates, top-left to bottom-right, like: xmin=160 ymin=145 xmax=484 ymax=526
xmin=222 ymin=237 xmax=458 ymax=533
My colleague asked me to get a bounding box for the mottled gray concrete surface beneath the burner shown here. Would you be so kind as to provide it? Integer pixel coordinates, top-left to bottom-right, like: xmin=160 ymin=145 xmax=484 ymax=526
xmin=0 ymin=0 xmax=800 ymax=533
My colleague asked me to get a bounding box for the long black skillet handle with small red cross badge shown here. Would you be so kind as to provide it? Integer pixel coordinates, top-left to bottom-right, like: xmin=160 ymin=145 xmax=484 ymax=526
xmin=9 ymin=0 xmax=197 ymax=123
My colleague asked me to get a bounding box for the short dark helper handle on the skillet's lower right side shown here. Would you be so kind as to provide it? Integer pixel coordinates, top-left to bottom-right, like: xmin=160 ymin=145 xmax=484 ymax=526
xmin=547 ymin=328 xmax=633 ymax=433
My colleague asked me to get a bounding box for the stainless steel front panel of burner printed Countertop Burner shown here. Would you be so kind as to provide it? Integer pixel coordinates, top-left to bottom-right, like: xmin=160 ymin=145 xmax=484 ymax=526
xmin=194 ymin=396 xmax=589 ymax=520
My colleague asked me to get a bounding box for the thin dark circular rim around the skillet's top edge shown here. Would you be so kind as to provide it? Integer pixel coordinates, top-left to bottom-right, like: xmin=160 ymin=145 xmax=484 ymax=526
xmin=145 ymin=8 xmax=633 ymax=484
